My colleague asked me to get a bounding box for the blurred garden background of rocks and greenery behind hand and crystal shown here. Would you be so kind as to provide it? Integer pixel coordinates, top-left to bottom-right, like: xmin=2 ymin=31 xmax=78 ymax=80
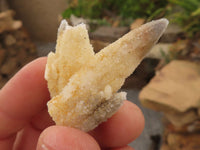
xmin=0 ymin=0 xmax=200 ymax=150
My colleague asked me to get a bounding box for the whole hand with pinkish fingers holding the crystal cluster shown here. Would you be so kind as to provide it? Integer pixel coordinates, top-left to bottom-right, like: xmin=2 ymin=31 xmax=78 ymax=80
xmin=0 ymin=58 xmax=144 ymax=150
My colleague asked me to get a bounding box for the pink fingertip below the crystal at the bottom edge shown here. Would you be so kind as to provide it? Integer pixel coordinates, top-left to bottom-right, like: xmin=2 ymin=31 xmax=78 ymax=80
xmin=37 ymin=126 xmax=100 ymax=150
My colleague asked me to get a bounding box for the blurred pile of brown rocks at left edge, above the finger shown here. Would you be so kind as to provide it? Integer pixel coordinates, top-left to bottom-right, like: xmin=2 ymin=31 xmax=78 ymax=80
xmin=0 ymin=9 xmax=37 ymax=88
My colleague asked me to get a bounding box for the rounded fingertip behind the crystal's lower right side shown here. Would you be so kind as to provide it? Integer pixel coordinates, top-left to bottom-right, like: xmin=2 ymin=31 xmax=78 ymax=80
xmin=90 ymin=101 xmax=144 ymax=147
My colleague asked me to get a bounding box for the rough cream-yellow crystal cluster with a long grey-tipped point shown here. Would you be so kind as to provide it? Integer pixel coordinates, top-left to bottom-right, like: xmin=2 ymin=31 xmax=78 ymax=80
xmin=45 ymin=19 xmax=168 ymax=131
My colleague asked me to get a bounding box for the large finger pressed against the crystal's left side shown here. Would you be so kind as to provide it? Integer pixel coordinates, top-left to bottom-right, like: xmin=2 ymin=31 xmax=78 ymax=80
xmin=0 ymin=58 xmax=49 ymax=139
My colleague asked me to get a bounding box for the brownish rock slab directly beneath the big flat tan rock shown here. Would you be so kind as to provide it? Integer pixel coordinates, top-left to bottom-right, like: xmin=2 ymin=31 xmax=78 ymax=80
xmin=165 ymin=110 xmax=199 ymax=127
